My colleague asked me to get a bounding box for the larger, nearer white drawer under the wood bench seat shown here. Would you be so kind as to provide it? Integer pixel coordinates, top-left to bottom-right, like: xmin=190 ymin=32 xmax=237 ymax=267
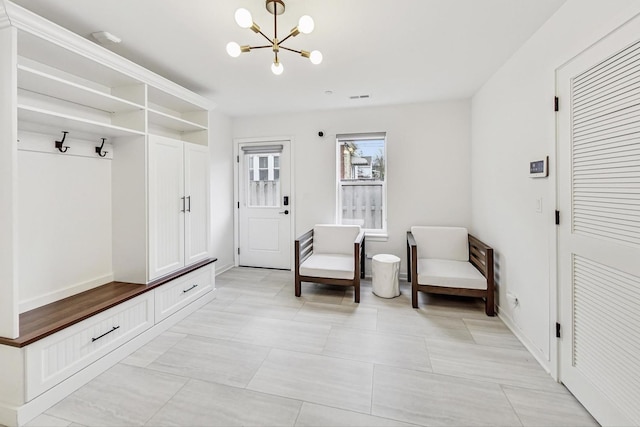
xmin=25 ymin=292 xmax=154 ymax=400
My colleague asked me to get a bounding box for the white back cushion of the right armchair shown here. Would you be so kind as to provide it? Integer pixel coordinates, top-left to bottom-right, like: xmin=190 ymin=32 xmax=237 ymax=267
xmin=411 ymin=226 xmax=469 ymax=261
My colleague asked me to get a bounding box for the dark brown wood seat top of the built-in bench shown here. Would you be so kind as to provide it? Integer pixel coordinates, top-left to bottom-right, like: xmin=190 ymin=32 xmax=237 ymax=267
xmin=0 ymin=258 xmax=217 ymax=347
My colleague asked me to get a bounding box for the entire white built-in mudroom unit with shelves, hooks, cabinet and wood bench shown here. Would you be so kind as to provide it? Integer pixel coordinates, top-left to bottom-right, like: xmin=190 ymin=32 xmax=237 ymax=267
xmin=0 ymin=0 xmax=216 ymax=426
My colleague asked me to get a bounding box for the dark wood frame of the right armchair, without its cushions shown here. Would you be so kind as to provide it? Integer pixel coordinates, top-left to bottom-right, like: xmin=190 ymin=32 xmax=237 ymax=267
xmin=407 ymin=231 xmax=495 ymax=316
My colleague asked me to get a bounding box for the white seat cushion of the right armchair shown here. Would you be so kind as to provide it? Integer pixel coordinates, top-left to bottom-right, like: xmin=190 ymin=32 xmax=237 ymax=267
xmin=418 ymin=258 xmax=487 ymax=290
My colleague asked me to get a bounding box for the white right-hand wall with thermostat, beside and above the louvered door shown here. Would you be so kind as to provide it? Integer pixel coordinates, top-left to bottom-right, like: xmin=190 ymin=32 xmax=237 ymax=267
xmin=471 ymin=0 xmax=640 ymax=373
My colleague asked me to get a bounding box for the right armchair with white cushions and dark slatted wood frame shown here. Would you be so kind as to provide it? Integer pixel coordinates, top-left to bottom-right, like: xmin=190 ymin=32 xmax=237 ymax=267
xmin=407 ymin=226 xmax=495 ymax=316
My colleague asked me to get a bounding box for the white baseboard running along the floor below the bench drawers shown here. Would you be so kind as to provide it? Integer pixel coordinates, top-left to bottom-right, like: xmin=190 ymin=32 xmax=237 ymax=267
xmin=0 ymin=288 xmax=216 ymax=427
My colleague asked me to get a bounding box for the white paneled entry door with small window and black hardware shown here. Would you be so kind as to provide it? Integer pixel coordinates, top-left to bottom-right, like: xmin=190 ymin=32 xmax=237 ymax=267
xmin=238 ymin=141 xmax=293 ymax=270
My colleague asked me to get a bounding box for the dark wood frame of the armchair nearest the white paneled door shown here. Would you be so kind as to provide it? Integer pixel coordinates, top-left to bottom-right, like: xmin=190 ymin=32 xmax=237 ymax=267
xmin=295 ymin=229 xmax=365 ymax=303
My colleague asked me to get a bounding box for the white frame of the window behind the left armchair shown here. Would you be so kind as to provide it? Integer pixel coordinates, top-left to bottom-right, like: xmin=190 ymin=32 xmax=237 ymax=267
xmin=335 ymin=132 xmax=389 ymax=237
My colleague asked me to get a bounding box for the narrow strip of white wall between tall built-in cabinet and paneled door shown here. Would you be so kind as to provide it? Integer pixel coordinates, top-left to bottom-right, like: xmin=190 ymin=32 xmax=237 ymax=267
xmin=209 ymin=110 xmax=234 ymax=271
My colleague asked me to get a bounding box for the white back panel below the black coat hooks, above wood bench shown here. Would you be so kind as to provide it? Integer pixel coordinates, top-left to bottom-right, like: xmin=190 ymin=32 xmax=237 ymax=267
xmin=17 ymin=137 xmax=113 ymax=312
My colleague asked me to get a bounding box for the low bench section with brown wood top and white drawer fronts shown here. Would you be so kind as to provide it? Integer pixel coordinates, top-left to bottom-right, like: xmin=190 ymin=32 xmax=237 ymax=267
xmin=0 ymin=259 xmax=215 ymax=424
